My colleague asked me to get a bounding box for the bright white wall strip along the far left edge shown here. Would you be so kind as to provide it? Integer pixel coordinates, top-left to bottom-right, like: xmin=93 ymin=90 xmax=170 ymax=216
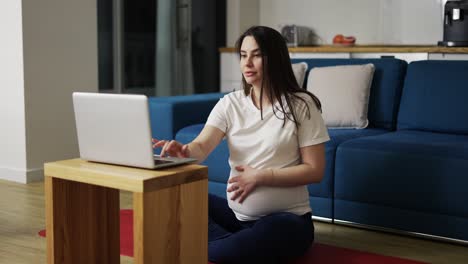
xmin=0 ymin=1 xmax=26 ymax=180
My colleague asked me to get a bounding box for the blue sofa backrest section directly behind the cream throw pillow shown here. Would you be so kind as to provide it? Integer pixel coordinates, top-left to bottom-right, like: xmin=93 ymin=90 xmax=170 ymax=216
xmin=291 ymin=58 xmax=407 ymax=130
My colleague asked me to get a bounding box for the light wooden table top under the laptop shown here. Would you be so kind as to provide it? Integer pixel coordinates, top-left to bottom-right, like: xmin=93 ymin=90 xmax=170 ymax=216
xmin=44 ymin=159 xmax=208 ymax=192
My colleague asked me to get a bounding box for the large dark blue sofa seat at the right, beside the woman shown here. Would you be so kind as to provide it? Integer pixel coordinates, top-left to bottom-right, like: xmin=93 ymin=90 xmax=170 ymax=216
xmin=335 ymin=131 xmax=468 ymax=221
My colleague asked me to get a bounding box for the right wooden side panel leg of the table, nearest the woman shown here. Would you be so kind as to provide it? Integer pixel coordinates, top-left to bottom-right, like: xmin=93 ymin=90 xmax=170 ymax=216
xmin=133 ymin=179 xmax=208 ymax=264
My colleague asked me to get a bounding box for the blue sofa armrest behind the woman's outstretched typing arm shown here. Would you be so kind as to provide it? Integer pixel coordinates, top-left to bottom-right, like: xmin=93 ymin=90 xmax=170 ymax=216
xmin=149 ymin=93 xmax=224 ymax=140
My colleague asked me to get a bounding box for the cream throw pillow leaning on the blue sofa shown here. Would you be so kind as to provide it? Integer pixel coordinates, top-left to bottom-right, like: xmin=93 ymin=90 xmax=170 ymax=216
xmin=307 ymin=63 xmax=375 ymax=128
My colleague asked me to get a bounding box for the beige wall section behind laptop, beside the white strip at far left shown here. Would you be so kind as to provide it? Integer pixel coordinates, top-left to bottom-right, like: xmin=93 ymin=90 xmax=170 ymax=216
xmin=23 ymin=0 xmax=98 ymax=179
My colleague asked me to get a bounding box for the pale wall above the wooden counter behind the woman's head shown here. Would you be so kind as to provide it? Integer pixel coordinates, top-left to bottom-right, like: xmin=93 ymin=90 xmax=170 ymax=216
xmin=227 ymin=0 xmax=445 ymax=46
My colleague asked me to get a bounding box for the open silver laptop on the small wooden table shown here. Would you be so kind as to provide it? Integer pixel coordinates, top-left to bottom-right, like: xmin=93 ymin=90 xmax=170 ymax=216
xmin=73 ymin=92 xmax=196 ymax=169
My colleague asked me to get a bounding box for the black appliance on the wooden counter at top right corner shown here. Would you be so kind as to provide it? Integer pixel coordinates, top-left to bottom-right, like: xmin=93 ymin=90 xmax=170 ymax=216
xmin=438 ymin=0 xmax=468 ymax=47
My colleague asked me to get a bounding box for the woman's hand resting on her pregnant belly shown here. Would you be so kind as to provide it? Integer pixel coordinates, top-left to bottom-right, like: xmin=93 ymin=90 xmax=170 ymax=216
xmin=227 ymin=165 xmax=260 ymax=203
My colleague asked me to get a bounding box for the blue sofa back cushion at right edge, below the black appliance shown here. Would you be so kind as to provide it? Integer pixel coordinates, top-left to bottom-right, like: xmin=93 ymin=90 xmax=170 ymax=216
xmin=397 ymin=60 xmax=468 ymax=134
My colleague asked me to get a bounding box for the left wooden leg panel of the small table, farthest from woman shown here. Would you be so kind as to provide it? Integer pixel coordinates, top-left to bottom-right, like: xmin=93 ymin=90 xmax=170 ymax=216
xmin=45 ymin=176 xmax=120 ymax=264
